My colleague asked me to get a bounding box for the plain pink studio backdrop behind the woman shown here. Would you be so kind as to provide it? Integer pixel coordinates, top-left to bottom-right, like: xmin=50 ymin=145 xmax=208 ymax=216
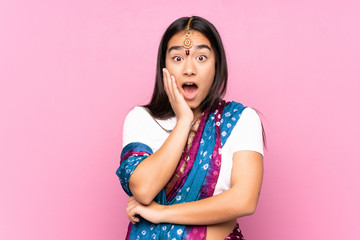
xmin=0 ymin=0 xmax=360 ymax=240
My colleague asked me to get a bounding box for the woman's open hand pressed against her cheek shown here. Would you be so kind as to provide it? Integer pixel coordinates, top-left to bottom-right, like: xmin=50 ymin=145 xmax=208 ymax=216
xmin=163 ymin=68 xmax=194 ymax=123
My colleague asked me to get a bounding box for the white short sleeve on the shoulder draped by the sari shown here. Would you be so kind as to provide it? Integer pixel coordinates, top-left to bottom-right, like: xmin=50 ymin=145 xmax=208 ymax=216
xmin=228 ymin=107 xmax=264 ymax=156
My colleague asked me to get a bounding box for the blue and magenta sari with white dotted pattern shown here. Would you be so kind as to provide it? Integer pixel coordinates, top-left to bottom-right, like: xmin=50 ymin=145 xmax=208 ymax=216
xmin=116 ymin=101 xmax=245 ymax=240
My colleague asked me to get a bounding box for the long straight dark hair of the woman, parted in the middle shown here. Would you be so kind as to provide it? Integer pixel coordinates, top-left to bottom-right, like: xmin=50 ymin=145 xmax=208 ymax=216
xmin=143 ymin=16 xmax=228 ymax=119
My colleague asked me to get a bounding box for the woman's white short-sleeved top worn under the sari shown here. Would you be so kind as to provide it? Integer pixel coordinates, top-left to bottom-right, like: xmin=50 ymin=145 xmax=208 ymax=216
xmin=123 ymin=107 xmax=264 ymax=195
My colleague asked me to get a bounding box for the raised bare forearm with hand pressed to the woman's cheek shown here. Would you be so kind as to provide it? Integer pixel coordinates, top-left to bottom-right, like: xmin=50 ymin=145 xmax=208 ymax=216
xmin=129 ymin=70 xmax=194 ymax=205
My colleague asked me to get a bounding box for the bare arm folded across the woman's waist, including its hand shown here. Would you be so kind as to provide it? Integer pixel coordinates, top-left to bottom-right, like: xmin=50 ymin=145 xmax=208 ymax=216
xmin=127 ymin=151 xmax=263 ymax=225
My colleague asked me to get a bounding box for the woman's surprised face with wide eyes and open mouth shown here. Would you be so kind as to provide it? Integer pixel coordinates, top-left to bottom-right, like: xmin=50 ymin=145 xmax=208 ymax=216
xmin=165 ymin=30 xmax=215 ymax=112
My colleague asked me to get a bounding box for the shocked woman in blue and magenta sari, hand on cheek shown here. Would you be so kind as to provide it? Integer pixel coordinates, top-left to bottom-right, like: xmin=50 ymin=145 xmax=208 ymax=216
xmin=117 ymin=16 xmax=263 ymax=240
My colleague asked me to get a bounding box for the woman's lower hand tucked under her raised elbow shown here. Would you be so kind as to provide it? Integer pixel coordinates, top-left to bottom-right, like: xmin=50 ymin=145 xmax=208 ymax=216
xmin=126 ymin=197 xmax=165 ymax=224
